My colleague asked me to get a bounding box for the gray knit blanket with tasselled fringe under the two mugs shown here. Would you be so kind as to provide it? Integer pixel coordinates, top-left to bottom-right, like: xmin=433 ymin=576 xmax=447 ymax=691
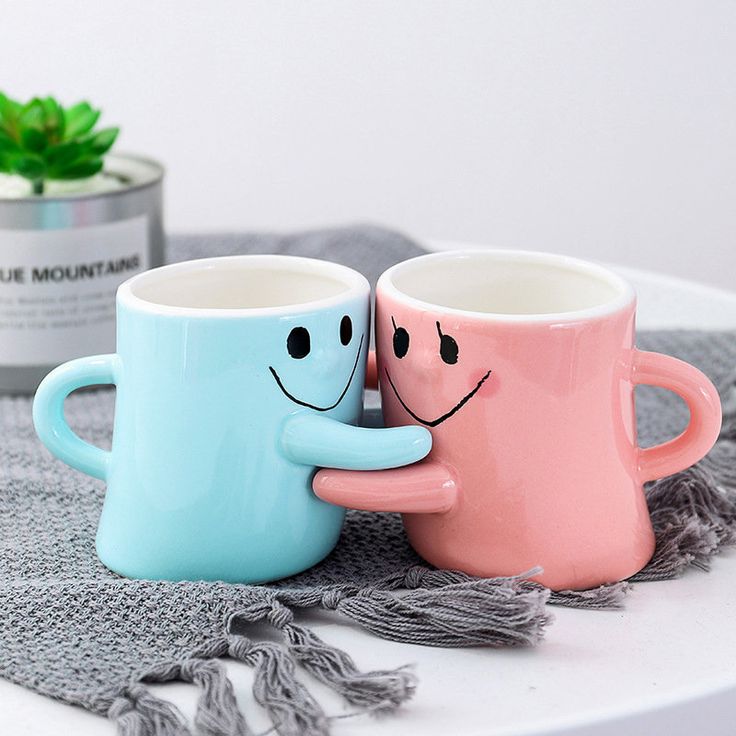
xmin=0 ymin=228 xmax=736 ymax=736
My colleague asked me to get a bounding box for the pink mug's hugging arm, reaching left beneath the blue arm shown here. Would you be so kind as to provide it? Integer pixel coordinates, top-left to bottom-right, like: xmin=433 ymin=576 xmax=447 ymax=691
xmin=312 ymin=461 xmax=457 ymax=514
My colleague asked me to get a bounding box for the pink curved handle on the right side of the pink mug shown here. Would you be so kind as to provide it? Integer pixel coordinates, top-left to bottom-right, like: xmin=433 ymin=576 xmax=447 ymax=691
xmin=632 ymin=349 xmax=721 ymax=482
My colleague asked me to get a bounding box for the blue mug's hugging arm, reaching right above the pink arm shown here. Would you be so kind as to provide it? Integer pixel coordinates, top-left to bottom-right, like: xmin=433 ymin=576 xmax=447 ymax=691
xmin=281 ymin=413 xmax=432 ymax=470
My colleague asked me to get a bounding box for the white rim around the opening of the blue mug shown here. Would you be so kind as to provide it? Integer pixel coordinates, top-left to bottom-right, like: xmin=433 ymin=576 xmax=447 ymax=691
xmin=116 ymin=253 xmax=371 ymax=319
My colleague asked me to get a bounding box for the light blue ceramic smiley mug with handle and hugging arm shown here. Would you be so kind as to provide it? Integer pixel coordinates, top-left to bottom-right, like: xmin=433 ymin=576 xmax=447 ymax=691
xmin=33 ymin=256 xmax=431 ymax=582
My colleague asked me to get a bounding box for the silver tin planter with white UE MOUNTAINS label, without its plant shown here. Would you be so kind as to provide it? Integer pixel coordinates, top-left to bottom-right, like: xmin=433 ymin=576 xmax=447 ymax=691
xmin=0 ymin=154 xmax=164 ymax=394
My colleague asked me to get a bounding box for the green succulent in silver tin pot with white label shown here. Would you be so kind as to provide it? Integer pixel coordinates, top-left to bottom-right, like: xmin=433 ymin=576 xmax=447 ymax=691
xmin=0 ymin=93 xmax=164 ymax=393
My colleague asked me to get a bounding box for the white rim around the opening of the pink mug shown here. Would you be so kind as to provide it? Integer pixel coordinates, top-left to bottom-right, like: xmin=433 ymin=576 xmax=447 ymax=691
xmin=376 ymin=248 xmax=636 ymax=323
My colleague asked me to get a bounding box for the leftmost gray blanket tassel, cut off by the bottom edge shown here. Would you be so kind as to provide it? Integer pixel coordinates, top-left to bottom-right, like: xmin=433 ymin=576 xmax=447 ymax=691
xmin=107 ymin=683 xmax=191 ymax=736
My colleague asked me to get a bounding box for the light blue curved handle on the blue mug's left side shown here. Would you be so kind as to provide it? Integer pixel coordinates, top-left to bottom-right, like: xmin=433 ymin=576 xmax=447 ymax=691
xmin=33 ymin=353 xmax=120 ymax=480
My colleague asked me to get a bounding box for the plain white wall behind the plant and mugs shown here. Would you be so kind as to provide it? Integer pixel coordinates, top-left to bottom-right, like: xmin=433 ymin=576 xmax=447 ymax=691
xmin=0 ymin=0 xmax=736 ymax=287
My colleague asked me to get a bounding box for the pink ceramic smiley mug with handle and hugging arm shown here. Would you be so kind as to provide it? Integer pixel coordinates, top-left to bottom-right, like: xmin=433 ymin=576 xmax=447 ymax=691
xmin=314 ymin=250 xmax=721 ymax=589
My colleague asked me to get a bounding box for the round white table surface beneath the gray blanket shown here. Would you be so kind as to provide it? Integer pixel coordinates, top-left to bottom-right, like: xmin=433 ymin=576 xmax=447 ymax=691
xmin=0 ymin=268 xmax=736 ymax=736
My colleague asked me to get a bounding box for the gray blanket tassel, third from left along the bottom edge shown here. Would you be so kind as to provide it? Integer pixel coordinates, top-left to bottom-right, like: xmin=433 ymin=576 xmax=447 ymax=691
xmin=228 ymin=635 xmax=329 ymax=736
